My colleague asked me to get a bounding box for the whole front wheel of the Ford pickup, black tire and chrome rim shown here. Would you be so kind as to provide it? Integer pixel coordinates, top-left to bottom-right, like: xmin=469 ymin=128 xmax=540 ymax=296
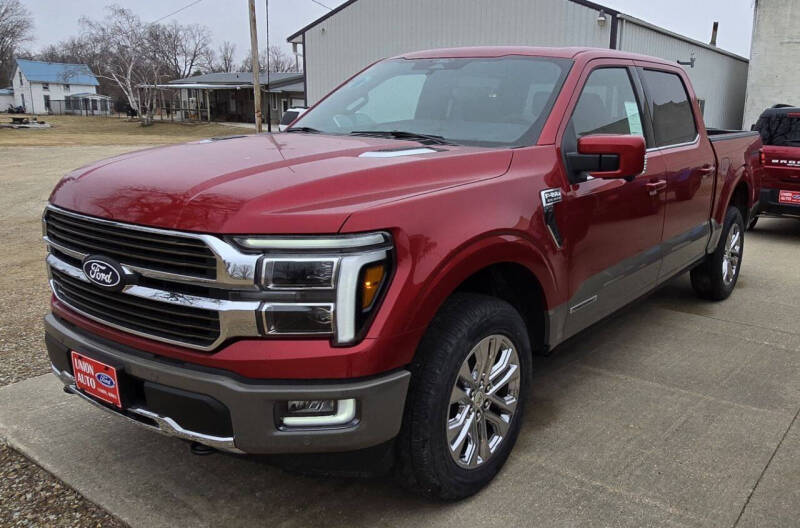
xmin=398 ymin=294 xmax=532 ymax=500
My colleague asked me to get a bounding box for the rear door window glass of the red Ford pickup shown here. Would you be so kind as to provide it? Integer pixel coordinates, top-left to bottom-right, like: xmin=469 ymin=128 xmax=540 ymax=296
xmin=642 ymin=70 xmax=697 ymax=147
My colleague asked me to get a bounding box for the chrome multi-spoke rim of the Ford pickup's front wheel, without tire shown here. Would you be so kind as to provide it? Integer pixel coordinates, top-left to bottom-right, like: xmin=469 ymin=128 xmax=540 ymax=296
xmin=445 ymin=334 xmax=520 ymax=469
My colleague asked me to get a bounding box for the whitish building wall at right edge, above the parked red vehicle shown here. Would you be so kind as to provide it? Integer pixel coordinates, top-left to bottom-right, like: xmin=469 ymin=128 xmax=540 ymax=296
xmin=743 ymin=0 xmax=800 ymax=128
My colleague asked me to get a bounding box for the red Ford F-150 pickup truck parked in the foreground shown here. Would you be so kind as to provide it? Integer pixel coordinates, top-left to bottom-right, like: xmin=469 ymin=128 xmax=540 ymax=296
xmin=43 ymin=47 xmax=761 ymax=499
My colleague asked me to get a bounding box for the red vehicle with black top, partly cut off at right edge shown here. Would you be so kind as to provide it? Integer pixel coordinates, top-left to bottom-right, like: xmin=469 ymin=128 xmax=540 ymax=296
xmin=750 ymin=105 xmax=800 ymax=227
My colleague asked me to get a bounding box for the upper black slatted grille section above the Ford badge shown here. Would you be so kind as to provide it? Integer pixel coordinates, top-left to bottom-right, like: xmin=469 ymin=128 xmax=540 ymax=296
xmin=44 ymin=209 xmax=217 ymax=280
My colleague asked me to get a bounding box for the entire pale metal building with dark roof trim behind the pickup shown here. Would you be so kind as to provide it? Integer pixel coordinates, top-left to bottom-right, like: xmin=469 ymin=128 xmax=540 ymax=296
xmin=288 ymin=0 xmax=752 ymax=128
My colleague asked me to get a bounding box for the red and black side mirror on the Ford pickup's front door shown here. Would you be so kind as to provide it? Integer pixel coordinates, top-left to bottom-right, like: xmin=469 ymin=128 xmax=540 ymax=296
xmin=567 ymin=134 xmax=646 ymax=181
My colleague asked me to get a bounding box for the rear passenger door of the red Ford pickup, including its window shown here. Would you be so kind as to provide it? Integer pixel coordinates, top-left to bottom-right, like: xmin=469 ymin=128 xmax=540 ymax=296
xmin=638 ymin=63 xmax=717 ymax=280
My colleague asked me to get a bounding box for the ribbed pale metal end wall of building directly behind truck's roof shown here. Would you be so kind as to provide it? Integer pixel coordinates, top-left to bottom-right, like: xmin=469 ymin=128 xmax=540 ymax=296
xmin=304 ymin=0 xmax=611 ymax=105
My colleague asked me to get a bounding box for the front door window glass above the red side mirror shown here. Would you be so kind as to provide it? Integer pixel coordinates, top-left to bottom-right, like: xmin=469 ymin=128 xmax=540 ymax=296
xmin=570 ymin=68 xmax=644 ymax=137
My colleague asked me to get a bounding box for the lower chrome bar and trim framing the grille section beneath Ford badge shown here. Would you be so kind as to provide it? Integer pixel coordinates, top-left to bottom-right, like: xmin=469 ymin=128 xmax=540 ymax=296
xmin=47 ymin=254 xmax=261 ymax=352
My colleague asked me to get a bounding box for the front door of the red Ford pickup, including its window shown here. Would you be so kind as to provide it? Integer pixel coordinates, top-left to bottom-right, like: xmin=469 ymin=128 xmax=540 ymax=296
xmin=562 ymin=61 xmax=666 ymax=337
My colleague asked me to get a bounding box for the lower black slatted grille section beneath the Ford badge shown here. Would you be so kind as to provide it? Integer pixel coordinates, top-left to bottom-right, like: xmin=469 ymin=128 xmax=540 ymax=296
xmin=50 ymin=268 xmax=220 ymax=347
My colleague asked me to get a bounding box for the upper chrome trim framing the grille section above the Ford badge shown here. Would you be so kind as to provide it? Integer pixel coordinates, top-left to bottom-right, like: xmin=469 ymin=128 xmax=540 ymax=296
xmin=42 ymin=204 xmax=260 ymax=290
